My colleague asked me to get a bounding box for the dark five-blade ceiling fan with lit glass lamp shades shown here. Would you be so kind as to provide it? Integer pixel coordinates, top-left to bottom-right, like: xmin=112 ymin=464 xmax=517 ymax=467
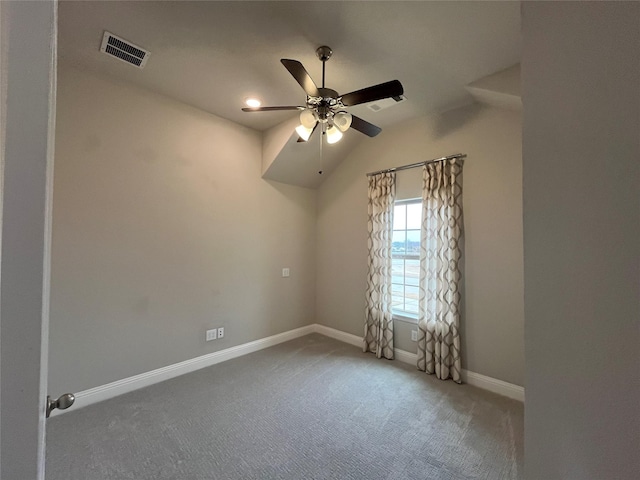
xmin=242 ymin=45 xmax=404 ymax=143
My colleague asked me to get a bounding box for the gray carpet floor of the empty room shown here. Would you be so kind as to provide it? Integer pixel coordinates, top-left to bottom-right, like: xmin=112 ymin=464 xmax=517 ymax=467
xmin=46 ymin=334 xmax=523 ymax=480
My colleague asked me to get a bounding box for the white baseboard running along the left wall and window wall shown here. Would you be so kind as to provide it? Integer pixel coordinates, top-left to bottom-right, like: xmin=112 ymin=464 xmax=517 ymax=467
xmin=57 ymin=323 xmax=524 ymax=416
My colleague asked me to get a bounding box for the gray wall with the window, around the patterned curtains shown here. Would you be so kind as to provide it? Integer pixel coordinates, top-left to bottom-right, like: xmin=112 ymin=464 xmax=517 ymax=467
xmin=317 ymin=105 xmax=524 ymax=385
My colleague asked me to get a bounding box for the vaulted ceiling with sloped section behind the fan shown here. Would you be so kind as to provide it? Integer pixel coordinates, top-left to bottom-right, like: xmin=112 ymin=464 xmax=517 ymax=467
xmin=58 ymin=1 xmax=520 ymax=187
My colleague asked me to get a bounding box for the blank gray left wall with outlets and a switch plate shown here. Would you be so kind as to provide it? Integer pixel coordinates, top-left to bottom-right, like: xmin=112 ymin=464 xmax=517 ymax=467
xmin=49 ymin=65 xmax=316 ymax=395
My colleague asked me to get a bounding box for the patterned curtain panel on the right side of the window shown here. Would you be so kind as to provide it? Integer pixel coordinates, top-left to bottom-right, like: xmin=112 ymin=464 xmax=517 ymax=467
xmin=418 ymin=159 xmax=463 ymax=383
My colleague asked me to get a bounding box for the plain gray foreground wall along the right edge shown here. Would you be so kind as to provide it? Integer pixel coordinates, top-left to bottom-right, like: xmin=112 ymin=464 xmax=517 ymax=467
xmin=522 ymin=2 xmax=640 ymax=480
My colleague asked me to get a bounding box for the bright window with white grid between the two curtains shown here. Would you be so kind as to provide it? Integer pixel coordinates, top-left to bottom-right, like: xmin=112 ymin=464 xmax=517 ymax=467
xmin=391 ymin=199 xmax=422 ymax=318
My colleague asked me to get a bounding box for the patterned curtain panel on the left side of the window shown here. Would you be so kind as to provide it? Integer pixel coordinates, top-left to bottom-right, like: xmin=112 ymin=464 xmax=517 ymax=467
xmin=363 ymin=172 xmax=396 ymax=359
